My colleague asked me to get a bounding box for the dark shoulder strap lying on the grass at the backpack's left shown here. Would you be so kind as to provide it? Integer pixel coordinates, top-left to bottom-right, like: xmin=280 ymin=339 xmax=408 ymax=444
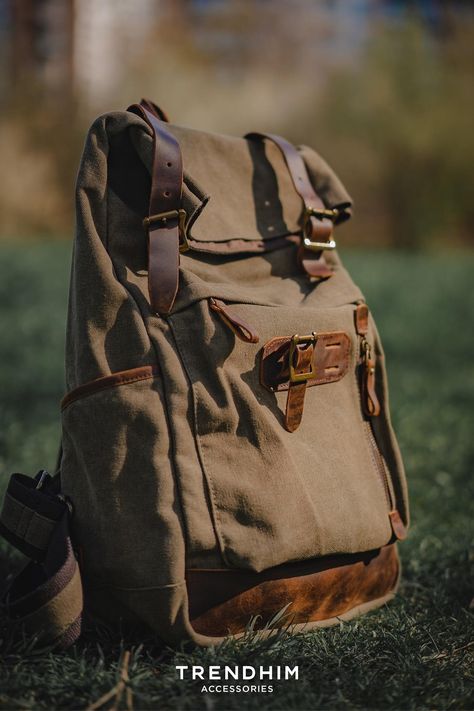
xmin=0 ymin=472 xmax=83 ymax=649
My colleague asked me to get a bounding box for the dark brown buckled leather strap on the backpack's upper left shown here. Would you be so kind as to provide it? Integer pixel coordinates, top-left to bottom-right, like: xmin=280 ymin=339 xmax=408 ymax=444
xmin=128 ymin=101 xmax=185 ymax=314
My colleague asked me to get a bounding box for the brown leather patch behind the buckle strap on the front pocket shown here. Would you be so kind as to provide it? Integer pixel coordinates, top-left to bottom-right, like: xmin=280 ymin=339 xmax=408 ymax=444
xmin=260 ymin=331 xmax=351 ymax=392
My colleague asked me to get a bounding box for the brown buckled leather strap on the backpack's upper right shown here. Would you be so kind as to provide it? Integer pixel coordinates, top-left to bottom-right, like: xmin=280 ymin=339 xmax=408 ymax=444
xmin=245 ymin=132 xmax=337 ymax=279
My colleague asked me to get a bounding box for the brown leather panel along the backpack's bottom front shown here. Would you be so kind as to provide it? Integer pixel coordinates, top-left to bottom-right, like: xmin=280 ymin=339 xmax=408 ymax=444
xmin=186 ymin=545 xmax=400 ymax=637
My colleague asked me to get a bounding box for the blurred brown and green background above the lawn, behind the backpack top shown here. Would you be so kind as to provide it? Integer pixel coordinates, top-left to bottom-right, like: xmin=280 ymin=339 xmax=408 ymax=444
xmin=0 ymin=0 xmax=474 ymax=249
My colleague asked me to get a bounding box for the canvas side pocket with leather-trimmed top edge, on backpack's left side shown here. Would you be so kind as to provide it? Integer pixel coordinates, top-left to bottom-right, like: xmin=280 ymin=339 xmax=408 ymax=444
xmin=61 ymin=366 xmax=189 ymax=587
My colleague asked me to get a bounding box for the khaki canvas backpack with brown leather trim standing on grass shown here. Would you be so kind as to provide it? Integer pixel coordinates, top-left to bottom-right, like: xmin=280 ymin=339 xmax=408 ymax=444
xmin=0 ymin=100 xmax=408 ymax=647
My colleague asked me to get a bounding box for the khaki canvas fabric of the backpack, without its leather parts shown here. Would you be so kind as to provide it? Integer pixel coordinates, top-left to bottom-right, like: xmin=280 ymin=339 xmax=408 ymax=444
xmin=61 ymin=112 xmax=408 ymax=644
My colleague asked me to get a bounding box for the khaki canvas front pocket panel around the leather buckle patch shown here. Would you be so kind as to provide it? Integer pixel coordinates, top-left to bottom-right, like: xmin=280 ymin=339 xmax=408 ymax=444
xmin=170 ymin=301 xmax=391 ymax=571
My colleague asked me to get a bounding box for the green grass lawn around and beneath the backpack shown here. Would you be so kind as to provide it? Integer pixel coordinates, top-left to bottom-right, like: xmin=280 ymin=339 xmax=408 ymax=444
xmin=0 ymin=245 xmax=474 ymax=709
